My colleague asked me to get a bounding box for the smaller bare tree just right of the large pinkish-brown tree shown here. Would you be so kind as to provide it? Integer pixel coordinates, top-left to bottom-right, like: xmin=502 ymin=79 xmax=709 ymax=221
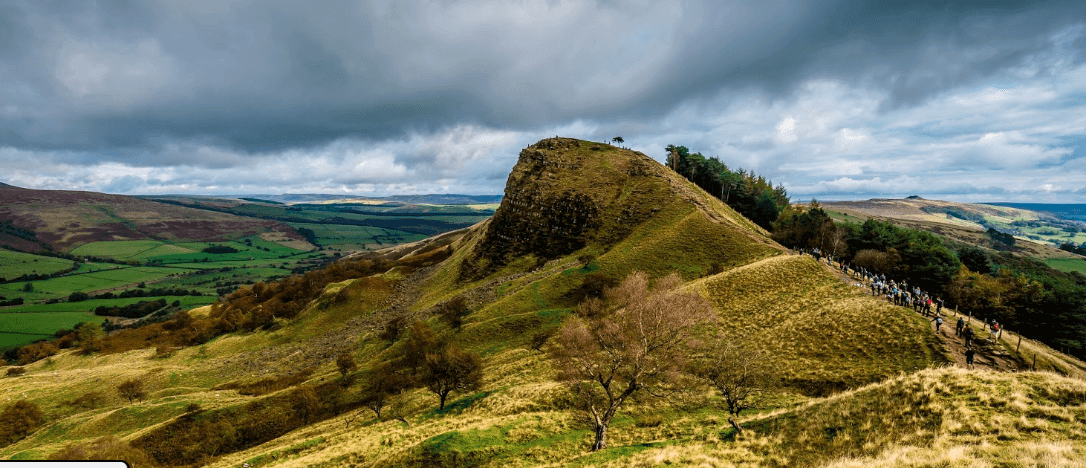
xmin=694 ymin=340 xmax=776 ymax=432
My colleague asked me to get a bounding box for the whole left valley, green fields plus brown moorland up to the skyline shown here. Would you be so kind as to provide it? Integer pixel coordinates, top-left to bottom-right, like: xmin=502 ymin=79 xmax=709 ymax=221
xmin=0 ymin=186 xmax=496 ymax=351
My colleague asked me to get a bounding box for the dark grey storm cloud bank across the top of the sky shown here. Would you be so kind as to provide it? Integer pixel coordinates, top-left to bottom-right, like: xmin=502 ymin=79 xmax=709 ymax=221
xmin=0 ymin=1 xmax=1082 ymax=158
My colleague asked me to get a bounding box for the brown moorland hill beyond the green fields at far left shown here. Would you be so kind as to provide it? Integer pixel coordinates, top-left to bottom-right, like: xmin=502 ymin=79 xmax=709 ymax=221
xmin=0 ymin=186 xmax=304 ymax=252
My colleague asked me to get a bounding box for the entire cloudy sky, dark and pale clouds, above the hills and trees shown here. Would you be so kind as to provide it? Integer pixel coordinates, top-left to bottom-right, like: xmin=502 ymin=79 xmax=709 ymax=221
xmin=0 ymin=0 xmax=1086 ymax=203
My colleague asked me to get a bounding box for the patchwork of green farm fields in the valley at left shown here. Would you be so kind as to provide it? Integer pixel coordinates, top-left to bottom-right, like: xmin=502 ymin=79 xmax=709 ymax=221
xmin=0 ymin=194 xmax=496 ymax=352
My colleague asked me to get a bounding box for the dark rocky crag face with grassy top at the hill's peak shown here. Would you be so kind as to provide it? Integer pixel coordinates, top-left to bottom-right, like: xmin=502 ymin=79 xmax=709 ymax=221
xmin=460 ymin=138 xmax=668 ymax=280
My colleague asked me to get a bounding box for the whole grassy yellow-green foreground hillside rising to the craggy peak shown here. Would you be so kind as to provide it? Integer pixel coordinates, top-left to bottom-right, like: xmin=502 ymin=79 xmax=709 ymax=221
xmin=0 ymin=138 xmax=1086 ymax=467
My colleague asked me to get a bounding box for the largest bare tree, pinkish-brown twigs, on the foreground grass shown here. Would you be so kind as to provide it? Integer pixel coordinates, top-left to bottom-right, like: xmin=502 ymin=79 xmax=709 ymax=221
xmin=551 ymin=271 xmax=717 ymax=451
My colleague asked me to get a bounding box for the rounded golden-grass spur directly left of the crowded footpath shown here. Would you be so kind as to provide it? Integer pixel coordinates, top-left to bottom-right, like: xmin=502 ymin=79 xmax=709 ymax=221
xmin=691 ymin=255 xmax=947 ymax=394
